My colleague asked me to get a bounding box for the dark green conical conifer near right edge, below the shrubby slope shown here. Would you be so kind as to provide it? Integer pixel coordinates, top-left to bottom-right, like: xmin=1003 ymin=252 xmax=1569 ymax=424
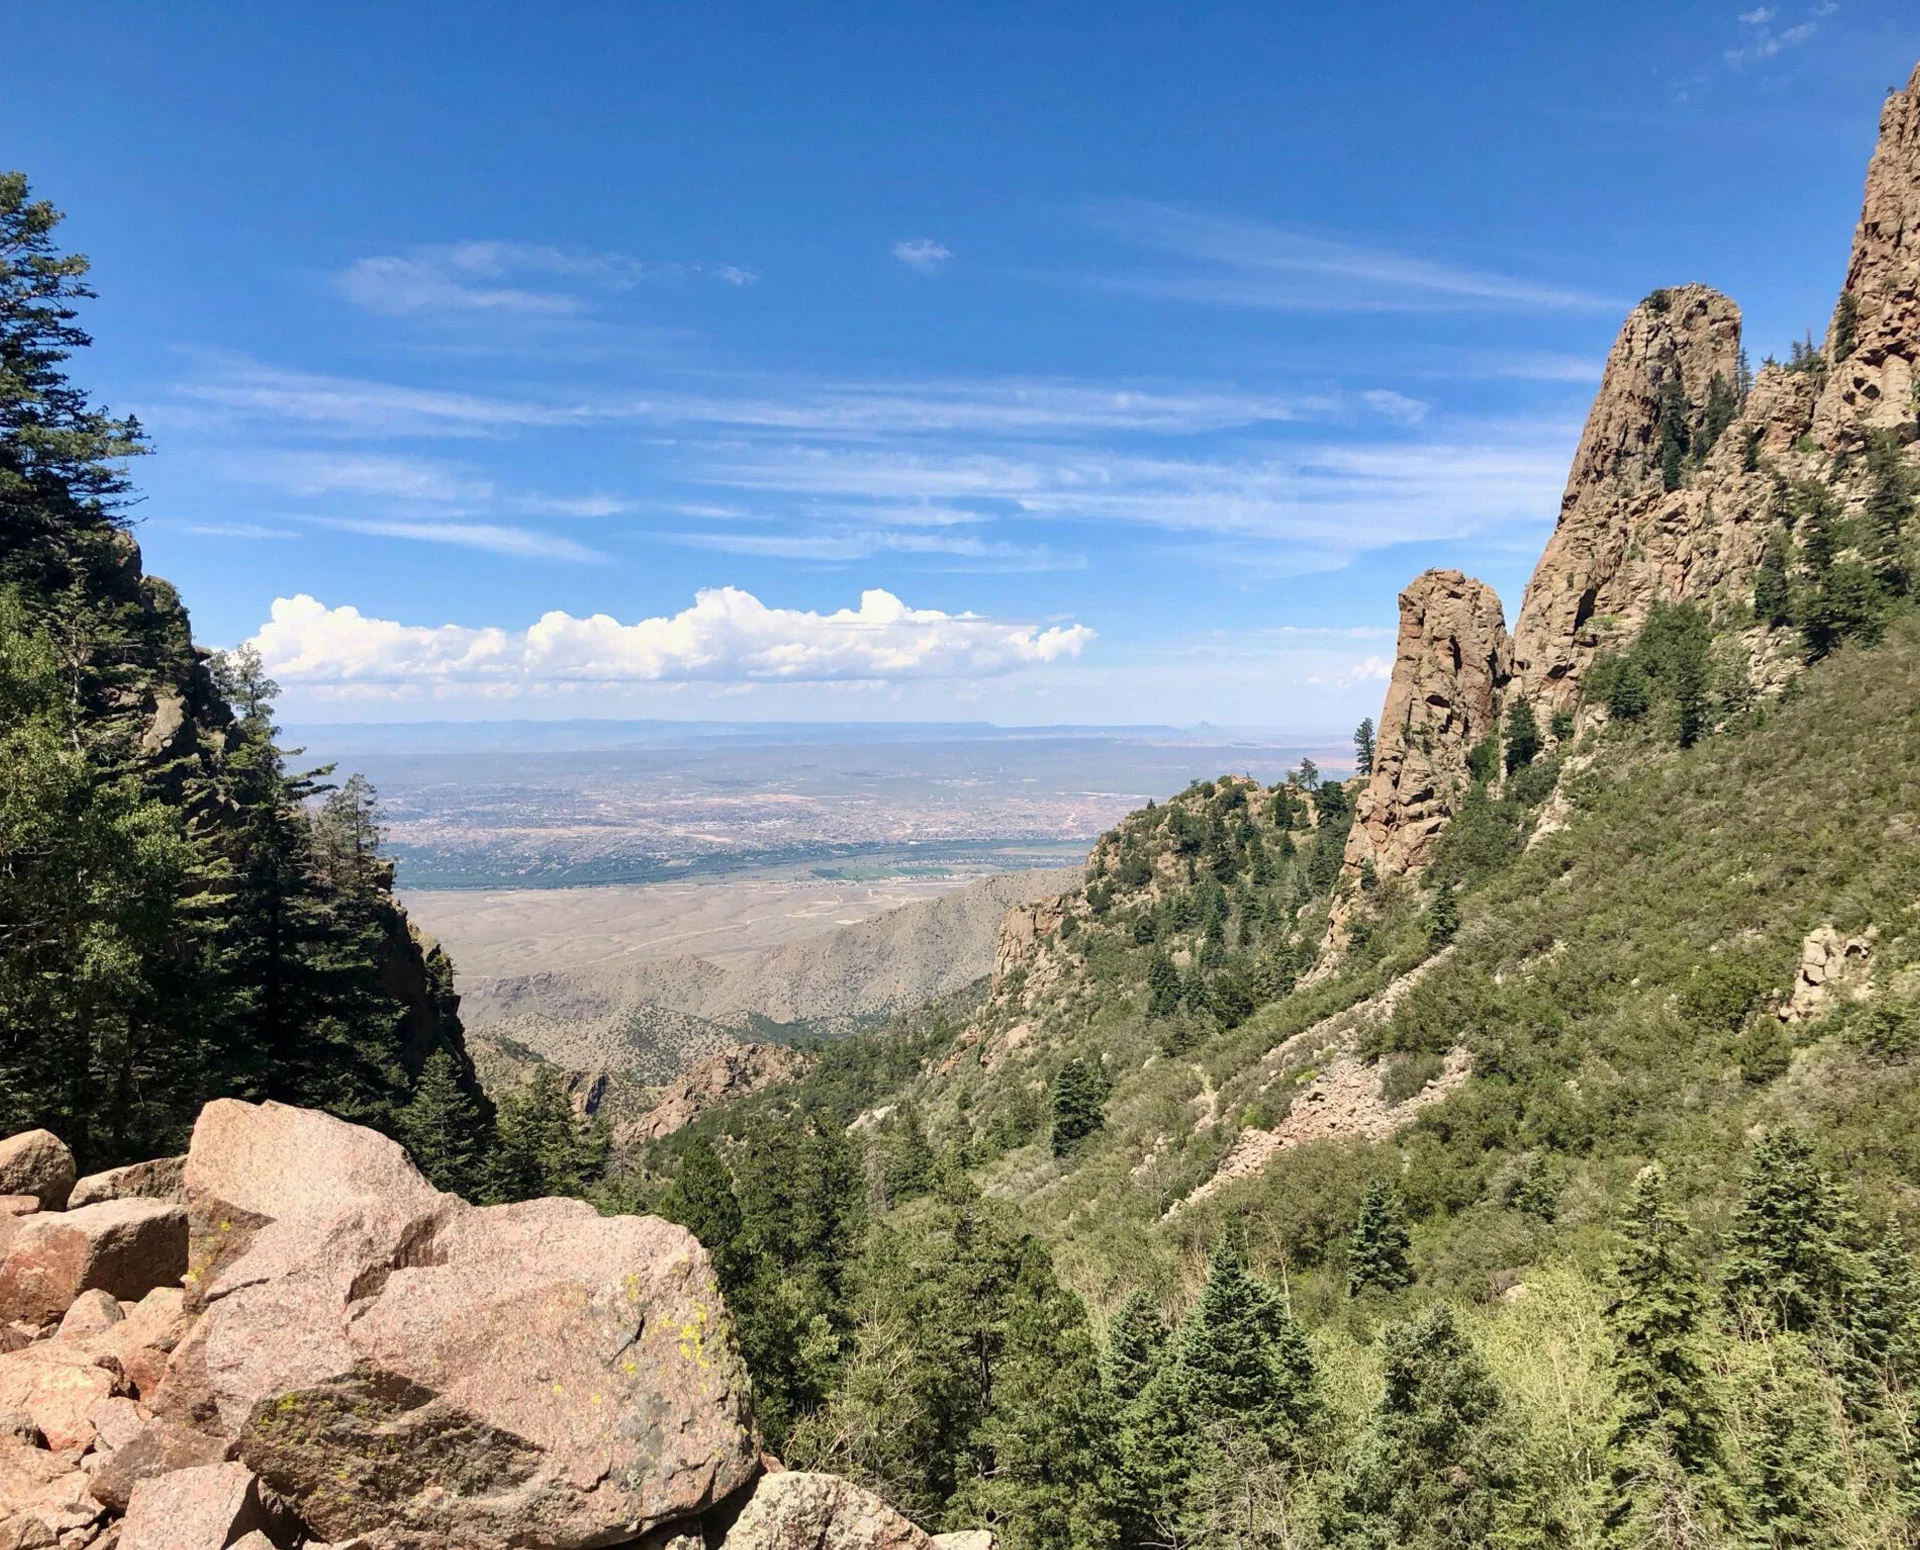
xmin=1722 ymin=1126 xmax=1853 ymax=1333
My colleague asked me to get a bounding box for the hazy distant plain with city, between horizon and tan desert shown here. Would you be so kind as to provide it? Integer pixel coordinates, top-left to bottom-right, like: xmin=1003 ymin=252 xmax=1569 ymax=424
xmin=286 ymin=720 xmax=1352 ymax=889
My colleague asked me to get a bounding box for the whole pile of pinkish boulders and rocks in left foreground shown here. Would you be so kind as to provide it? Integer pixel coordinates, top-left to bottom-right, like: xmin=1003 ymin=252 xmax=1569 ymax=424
xmin=0 ymin=1099 xmax=991 ymax=1550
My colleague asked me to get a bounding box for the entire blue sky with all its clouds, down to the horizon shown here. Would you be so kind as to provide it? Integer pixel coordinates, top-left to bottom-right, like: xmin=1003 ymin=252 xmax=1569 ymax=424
xmin=0 ymin=0 xmax=1920 ymax=730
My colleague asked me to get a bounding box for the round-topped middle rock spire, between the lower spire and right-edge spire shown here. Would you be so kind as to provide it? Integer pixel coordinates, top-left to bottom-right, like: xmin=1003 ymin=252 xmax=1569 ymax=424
xmin=1513 ymin=286 xmax=1740 ymax=709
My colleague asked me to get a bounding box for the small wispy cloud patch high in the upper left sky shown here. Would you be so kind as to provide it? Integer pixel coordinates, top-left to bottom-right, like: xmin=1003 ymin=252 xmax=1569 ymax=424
xmin=334 ymin=242 xmax=758 ymax=315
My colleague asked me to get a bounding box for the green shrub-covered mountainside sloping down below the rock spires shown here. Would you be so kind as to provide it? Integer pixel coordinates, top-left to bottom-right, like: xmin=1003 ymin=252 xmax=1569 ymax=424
xmin=633 ymin=613 xmax=1920 ymax=1544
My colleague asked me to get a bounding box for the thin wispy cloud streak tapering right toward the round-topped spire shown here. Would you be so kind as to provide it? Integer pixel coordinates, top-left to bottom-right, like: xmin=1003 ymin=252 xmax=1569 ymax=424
xmin=1079 ymin=200 xmax=1619 ymax=311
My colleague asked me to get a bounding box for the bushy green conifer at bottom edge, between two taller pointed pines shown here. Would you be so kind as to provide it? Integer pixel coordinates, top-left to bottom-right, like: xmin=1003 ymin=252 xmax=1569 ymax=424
xmin=1325 ymin=1302 xmax=1521 ymax=1550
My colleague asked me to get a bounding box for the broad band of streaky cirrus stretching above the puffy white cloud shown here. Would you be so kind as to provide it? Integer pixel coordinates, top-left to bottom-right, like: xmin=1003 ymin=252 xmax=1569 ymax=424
xmin=165 ymin=357 xmax=1586 ymax=574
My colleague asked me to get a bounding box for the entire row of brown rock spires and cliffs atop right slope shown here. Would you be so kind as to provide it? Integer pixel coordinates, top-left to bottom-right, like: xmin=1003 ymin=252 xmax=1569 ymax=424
xmin=1334 ymin=69 xmax=1920 ymax=910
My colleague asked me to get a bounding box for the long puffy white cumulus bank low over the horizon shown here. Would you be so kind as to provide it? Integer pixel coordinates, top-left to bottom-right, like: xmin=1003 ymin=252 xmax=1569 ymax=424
xmin=250 ymin=586 xmax=1094 ymax=690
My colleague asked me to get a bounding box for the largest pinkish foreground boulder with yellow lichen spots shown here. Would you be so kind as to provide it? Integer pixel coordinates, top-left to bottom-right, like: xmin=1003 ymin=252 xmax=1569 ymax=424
xmin=156 ymin=1101 xmax=758 ymax=1550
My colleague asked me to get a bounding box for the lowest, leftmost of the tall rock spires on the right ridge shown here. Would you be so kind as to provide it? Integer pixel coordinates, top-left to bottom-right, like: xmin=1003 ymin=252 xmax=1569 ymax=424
xmin=1346 ymin=570 xmax=1509 ymax=878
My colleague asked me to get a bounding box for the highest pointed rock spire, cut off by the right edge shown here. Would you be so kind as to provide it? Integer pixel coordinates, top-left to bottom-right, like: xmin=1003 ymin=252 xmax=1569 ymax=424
xmin=1814 ymin=67 xmax=1920 ymax=451
